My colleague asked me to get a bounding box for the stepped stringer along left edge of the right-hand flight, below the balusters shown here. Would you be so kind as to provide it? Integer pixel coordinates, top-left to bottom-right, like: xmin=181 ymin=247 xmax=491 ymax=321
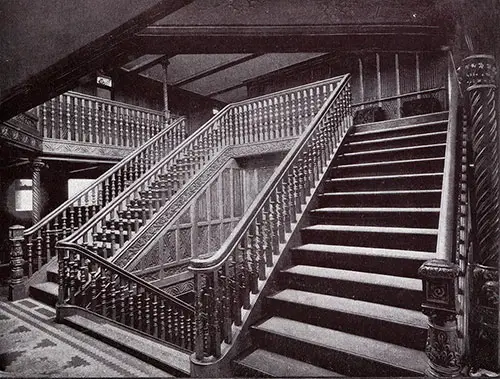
xmin=191 ymin=135 xmax=352 ymax=378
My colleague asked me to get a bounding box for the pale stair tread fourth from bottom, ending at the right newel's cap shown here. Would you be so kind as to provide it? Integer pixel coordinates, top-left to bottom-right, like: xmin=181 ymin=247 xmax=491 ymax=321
xmin=282 ymin=265 xmax=422 ymax=291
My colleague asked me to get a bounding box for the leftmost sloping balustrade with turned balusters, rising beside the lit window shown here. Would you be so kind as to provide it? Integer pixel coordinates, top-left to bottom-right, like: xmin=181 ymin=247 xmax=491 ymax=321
xmin=19 ymin=118 xmax=186 ymax=277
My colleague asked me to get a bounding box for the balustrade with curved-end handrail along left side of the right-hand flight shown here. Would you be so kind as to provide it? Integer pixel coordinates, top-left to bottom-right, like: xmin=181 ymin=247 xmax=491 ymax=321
xmin=190 ymin=75 xmax=352 ymax=361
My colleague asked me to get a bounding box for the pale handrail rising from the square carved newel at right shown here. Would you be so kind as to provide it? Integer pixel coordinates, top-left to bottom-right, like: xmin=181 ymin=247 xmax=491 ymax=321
xmin=436 ymin=54 xmax=459 ymax=262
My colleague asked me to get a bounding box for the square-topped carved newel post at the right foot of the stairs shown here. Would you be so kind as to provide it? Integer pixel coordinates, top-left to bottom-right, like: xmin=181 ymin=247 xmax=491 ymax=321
xmin=418 ymin=259 xmax=463 ymax=377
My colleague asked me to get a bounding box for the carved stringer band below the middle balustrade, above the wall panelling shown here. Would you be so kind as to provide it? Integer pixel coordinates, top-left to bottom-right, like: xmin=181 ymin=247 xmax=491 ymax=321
xmin=111 ymin=137 xmax=297 ymax=272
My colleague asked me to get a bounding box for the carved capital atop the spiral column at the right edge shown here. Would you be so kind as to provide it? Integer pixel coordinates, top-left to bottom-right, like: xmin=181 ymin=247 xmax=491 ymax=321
xmin=458 ymin=54 xmax=497 ymax=91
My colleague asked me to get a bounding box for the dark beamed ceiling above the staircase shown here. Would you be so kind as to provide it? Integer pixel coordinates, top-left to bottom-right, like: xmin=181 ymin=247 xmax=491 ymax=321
xmin=0 ymin=0 xmax=446 ymax=119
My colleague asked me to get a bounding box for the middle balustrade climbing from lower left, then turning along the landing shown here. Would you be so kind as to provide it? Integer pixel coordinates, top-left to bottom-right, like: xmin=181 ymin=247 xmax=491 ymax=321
xmin=56 ymin=75 xmax=339 ymax=264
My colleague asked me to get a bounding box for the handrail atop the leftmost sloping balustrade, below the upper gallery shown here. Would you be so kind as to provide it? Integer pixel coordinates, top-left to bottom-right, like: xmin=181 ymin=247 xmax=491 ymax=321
xmin=24 ymin=117 xmax=186 ymax=236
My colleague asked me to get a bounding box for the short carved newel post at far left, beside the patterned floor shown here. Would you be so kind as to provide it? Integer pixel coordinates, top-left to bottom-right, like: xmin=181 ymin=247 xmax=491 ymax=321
xmin=8 ymin=225 xmax=26 ymax=301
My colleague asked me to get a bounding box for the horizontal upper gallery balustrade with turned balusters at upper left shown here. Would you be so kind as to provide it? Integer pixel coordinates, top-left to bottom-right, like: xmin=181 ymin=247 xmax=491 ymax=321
xmin=37 ymin=92 xmax=165 ymax=148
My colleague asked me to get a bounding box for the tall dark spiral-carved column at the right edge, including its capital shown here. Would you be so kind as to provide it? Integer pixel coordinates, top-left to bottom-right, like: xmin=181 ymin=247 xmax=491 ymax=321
xmin=460 ymin=55 xmax=500 ymax=371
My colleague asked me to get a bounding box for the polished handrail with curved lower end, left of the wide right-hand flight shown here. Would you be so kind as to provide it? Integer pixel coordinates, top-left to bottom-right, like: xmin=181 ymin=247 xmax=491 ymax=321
xmin=189 ymin=74 xmax=350 ymax=273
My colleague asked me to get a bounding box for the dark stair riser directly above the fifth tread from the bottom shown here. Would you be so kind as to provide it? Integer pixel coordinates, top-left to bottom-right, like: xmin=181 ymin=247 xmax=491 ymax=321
xmin=302 ymin=229 xmax=436 ymax=252
